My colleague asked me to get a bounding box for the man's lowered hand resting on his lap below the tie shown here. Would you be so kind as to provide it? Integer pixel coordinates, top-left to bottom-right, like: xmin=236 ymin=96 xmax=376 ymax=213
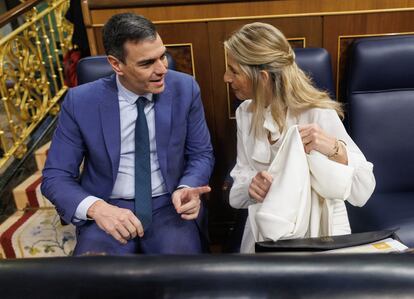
xmin=87 ymin=200 xmax=144 ymax=244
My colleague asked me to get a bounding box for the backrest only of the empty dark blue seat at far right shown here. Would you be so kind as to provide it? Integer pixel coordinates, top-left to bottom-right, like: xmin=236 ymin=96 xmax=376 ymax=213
xmin=347 ymin=36 xmax=414 ymax=192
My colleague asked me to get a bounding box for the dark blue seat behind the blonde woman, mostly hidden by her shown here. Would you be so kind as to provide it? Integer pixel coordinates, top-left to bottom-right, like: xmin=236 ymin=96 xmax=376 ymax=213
xmin=223 ymin=48 xmax=335 ymax=252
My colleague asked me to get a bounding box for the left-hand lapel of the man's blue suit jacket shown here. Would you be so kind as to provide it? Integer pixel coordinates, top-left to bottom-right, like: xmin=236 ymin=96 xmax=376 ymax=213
xmin=99 ymin=75 xmax=121 ymax=182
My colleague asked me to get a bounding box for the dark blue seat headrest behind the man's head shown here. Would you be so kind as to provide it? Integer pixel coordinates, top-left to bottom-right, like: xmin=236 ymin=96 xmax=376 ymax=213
xmin=76 ymin=53 xmax=176 ymax=85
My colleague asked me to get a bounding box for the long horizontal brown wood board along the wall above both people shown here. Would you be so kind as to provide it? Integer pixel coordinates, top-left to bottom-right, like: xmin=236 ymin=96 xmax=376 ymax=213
xmin=83 ymin=0 xmax=414 ymax=24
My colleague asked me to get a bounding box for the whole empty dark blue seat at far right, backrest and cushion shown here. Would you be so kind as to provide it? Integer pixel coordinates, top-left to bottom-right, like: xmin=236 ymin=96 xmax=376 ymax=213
xmin=347 ymin=36 xmax=414 ymax=247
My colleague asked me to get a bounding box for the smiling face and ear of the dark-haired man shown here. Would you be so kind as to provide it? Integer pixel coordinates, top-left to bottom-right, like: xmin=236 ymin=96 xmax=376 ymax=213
xmin=108 ymin=34 xmax=168 ymax=95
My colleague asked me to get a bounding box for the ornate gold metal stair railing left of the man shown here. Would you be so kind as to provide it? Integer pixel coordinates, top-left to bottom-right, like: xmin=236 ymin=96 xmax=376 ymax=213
xmin=0 ymin=0 xmax=73 ymax=168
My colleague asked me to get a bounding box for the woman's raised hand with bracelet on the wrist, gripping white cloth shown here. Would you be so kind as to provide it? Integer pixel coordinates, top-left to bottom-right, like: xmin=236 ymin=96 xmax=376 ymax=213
xmin=299 ymin=123 xmax=348 ymax=165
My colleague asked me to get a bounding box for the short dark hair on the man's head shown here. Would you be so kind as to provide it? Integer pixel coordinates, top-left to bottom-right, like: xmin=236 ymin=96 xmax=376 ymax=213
xmin=102 ymin=13 xmax=157 ymax=63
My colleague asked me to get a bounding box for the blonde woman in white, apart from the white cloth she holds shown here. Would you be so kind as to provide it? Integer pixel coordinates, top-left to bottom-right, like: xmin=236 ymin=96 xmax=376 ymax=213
xmin=224 ymin=23 xmax=375 ymax=253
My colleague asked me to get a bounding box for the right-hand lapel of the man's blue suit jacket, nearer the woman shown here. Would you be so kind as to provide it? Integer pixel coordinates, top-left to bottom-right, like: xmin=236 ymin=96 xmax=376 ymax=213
xmin=154 ymin=88 xmax=173 ymax=186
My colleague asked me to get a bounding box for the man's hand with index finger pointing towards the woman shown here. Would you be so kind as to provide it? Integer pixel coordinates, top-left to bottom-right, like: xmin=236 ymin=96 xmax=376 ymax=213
xmin=172 ymin=186 xmax=211 ymax=220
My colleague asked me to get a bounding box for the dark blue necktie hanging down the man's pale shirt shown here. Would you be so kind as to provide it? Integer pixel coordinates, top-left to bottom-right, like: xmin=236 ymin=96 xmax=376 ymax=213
xmin=135 ymin=97 xmax=152 ymax=230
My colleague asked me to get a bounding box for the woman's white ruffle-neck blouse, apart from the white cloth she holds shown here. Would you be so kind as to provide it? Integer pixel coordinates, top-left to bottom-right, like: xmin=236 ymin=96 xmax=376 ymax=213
xmin=230 ymin=100 xmax=375 ymax=252
